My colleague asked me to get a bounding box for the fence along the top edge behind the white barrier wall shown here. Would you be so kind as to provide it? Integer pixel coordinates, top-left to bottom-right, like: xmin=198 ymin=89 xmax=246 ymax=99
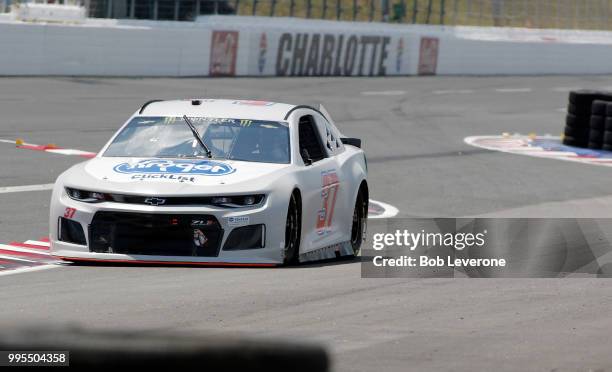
xmin=0 ymin=0 xmax=612 ymax=30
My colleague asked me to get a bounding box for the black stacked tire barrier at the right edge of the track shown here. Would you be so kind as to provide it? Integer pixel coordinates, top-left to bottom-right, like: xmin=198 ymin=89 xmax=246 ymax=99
xmin=563 ymin=90 xmax=612 ymax=151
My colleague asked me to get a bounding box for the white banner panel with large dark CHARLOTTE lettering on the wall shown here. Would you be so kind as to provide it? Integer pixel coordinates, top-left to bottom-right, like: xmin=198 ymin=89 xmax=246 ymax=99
xmin=248 ymin=30 xmax=418 ymax=76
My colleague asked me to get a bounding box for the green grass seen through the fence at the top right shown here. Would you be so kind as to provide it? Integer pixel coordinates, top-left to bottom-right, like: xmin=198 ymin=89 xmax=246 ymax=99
xmin=229 ymin=0 xmax=612 ymax=30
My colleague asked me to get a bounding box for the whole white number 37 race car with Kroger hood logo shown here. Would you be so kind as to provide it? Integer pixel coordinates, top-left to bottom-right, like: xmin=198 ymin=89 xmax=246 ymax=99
xmin=50 ymin=99 xmax=369 ymax=266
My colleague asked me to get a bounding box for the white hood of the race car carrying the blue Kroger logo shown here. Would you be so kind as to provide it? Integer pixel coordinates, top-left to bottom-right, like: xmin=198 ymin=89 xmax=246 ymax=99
xmin=62 ymin=157 xmax=290 ymax=195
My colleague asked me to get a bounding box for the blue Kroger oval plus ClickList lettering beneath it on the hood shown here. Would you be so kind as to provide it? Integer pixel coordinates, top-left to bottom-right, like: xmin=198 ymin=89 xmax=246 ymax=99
xmin=113 ymin=159 xmax=236 ymax=182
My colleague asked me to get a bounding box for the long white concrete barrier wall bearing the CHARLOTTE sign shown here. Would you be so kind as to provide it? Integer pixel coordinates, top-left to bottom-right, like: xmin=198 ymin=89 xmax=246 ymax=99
xmin=0 ymin=16 xmax=612 ymax=76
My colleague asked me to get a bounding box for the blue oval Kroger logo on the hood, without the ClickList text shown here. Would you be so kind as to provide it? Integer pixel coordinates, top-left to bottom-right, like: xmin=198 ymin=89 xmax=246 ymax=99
xmin=113 ymin=159 xmax=235 ymax=176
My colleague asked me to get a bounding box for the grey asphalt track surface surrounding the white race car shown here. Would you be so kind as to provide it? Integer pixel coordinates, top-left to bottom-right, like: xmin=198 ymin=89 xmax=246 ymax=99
xmin=0 ymin=76 xmax=612 ymax=371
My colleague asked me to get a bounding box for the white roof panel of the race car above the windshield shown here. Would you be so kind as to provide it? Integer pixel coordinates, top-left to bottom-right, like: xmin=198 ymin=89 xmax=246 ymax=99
xmin=138 ymin=98 xmax=297 ymax=121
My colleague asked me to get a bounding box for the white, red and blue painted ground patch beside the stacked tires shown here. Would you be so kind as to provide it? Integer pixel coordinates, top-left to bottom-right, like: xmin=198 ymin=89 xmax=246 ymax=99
xmin=465 ymin=134 xmax=612 ymax=166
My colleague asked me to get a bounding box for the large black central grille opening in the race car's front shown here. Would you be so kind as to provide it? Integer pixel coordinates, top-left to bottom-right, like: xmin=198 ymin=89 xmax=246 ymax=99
xmin=89 ymin=212 xmax=223 ymax=257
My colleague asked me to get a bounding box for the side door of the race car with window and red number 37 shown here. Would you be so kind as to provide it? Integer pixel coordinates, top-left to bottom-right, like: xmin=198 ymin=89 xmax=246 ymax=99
xmin=298 ymin=113 xmax=343 ymax=252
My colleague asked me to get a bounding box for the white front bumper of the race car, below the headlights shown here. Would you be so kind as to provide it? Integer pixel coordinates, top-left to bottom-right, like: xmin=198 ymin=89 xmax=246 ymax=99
xmin=50 ymin=192 xmax=286 ymax=266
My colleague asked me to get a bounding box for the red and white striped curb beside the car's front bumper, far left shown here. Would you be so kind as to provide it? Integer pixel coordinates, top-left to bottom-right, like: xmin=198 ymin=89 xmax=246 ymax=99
xmin=0 ymin=238 xmax=62 ymax=276
